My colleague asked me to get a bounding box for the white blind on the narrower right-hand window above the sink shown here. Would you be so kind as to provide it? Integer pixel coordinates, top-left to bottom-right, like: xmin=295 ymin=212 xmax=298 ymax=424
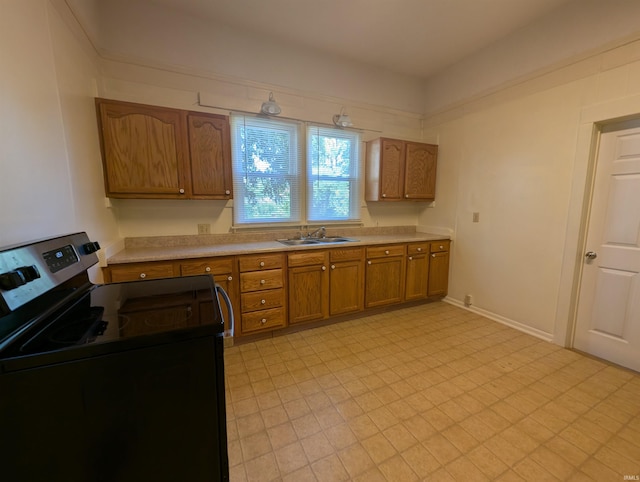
xmin=307 ymin=126 xmax=360 ymax=222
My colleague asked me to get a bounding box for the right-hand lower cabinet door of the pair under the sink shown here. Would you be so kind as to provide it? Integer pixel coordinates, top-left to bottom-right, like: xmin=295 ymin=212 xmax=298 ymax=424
xmin=329 ymin=259 xmax=364 ymax=316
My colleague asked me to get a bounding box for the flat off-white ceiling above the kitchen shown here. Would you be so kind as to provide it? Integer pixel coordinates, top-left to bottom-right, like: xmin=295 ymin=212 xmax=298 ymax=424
xmin=142 ymin=0 xmax=569 ymax=78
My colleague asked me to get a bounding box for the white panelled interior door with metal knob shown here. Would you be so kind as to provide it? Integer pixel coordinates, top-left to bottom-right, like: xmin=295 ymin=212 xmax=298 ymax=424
xmin=574 ymin=122 xmax=640 ymax=371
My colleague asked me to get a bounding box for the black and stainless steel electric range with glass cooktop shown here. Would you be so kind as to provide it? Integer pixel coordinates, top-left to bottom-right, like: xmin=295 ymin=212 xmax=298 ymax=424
xmin=0 ymin=233 xmax=229 ymax=482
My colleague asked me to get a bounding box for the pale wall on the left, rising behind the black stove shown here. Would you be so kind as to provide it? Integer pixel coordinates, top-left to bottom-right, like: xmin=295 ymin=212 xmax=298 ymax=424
xmin=0 ymin=0 xmax=118 ymax=274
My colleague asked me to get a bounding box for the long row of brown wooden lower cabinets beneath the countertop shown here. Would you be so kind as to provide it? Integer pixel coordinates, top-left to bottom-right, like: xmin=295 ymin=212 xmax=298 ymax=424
xmin=104 ymin=240 xmax=450 ymax=336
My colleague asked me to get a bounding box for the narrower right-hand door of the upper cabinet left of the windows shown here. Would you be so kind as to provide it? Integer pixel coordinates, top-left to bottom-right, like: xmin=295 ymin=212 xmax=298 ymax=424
xmin=188 ymin=113 xmax=233 ymax=199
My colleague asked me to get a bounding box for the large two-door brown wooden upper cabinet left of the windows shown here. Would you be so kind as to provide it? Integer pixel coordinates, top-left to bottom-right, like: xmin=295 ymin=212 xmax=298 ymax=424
xmin=96 ymin=99 xmax=232 ymax=199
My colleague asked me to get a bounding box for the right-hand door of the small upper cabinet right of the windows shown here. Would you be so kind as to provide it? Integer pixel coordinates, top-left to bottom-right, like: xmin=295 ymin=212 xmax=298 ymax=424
xmin=404 ymin=142 xmax=438 ymax=199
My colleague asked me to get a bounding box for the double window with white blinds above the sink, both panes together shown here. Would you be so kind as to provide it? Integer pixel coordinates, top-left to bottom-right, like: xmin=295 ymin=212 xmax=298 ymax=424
xmin=231 ymin=115 xmax=360 ymax=225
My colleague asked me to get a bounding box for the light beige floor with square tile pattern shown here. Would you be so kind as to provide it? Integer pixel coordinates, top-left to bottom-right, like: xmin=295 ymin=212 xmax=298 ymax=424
xmin=225 ymin=302 xmax=640 ymax=482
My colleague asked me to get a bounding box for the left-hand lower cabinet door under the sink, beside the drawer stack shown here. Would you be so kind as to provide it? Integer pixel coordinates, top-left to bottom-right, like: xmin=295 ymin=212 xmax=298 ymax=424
xmin=289 ymin=264 xmax=329 ymax=323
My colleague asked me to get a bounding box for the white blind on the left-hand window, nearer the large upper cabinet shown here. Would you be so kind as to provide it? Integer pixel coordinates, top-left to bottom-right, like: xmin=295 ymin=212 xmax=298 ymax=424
xmin=231 ymin=115 xmax=304 ymax=225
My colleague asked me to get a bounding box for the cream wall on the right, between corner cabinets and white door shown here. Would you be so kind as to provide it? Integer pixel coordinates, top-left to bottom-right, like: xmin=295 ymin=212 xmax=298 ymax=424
xmin=419 ymin=36 xmax=640 ymax=343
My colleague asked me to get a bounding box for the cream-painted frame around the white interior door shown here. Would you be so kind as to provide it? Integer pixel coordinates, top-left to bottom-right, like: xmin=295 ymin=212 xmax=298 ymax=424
xmin=553 ymin=95 xmax=640 ymax=348
